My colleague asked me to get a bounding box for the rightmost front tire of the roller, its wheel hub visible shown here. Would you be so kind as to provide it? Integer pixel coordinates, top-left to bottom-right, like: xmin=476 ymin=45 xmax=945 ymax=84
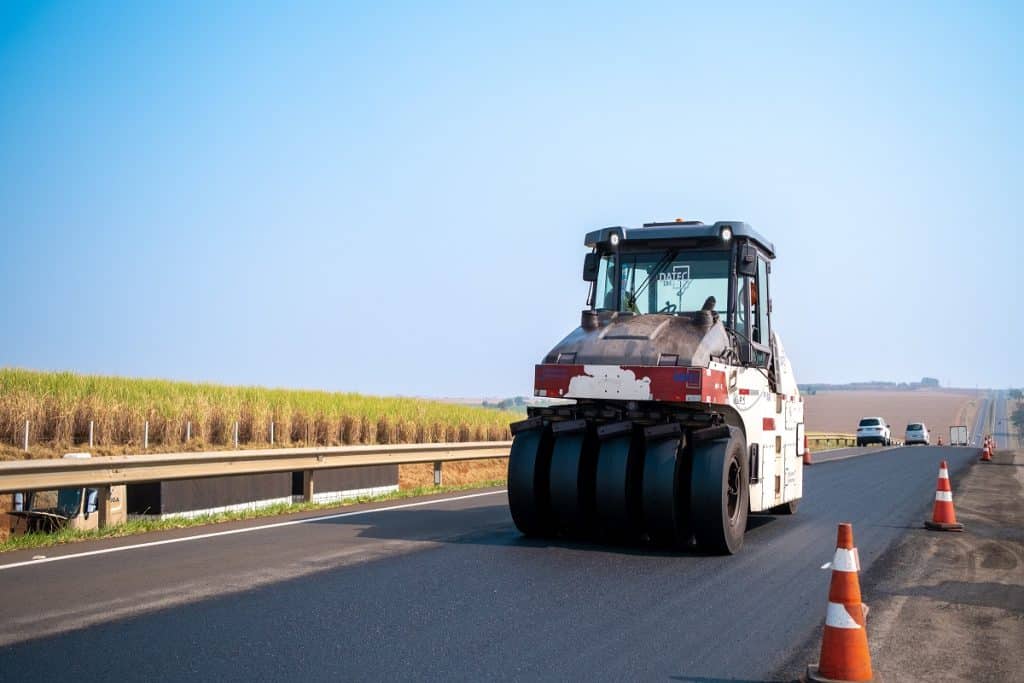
xmin=690 ymin=427 xmax=751 ymax=555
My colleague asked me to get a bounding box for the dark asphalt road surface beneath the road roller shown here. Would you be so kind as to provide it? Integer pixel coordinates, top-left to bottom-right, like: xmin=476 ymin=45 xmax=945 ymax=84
xmin=0 ymin=446 xmax=977 ymax=681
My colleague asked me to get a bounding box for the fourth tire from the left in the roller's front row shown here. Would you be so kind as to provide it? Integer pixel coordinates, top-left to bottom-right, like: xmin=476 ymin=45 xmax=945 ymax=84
xmin=640 ymin=436 xmax=689 ymax=546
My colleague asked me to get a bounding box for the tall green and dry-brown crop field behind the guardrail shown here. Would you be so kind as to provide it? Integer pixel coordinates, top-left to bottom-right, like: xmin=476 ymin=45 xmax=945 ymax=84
xmin=0 ymin=369 xmax=521 ymax=451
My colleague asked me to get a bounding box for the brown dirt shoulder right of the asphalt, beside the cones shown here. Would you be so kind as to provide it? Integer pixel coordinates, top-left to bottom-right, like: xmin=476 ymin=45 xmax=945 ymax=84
xmin=863 ymin=451 xmax=1024 ymax=681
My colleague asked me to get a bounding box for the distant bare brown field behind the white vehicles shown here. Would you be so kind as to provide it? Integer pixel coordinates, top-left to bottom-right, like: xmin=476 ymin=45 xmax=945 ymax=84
xmin=804 ymin=390 xmax=978 ymax=438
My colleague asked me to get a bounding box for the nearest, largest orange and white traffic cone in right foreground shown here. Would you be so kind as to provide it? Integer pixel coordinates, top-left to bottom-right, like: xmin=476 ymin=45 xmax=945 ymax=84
xmin=807 ymin=522 xmax=871 ymax=681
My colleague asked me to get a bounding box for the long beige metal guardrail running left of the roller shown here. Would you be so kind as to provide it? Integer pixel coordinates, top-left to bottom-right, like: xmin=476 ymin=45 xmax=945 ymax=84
xmin=0 ymin=441 xmax=512 ymax=494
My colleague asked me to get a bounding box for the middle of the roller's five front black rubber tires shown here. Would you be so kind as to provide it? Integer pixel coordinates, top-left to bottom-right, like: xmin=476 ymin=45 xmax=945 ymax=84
xmin=594 ymin=434 xmax=643 ymax=537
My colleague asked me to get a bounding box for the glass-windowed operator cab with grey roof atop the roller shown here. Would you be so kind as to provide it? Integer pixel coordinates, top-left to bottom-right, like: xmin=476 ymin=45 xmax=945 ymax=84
xmin=584 ymin=220 xmax=775 ymax=368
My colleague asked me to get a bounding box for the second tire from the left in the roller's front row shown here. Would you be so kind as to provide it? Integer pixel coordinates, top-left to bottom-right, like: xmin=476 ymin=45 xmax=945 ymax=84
xmin=548 ymin=429 xmax=597 ymax=533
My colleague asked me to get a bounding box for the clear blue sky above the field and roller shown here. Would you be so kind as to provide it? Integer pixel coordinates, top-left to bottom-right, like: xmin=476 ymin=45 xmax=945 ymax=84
xmin=0 ymin=0 xmax=1024 ymax=396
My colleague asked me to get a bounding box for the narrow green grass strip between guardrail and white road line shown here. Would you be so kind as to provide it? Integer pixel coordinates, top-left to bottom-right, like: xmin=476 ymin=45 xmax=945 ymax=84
xmin=0 ymin=479 xmax=505 ymax=553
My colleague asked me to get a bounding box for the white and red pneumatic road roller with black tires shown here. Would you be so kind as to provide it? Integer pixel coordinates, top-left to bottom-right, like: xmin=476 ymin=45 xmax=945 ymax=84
xmin=508 ymin=220 xmax=806 ymax=554
